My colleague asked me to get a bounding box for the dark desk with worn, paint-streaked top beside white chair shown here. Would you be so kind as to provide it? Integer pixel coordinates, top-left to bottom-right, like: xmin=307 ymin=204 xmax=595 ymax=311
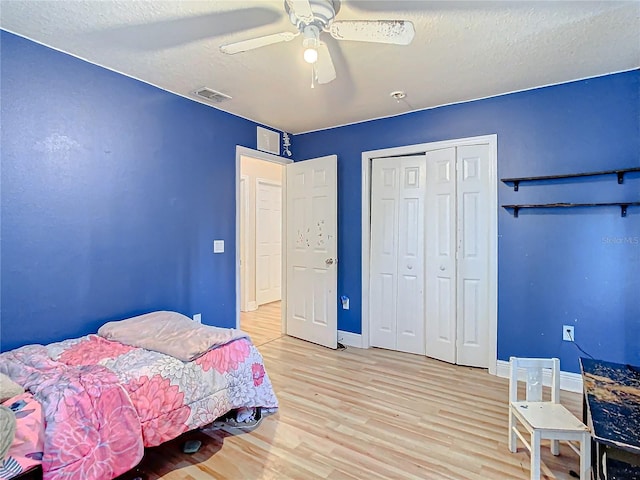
xmin=580 ymin=358 xmax=640 ymax=480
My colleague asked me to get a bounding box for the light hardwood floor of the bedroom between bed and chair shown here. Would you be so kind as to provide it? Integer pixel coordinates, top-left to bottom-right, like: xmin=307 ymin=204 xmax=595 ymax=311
xmin=126 ymin=310 xmax=581 ymax=480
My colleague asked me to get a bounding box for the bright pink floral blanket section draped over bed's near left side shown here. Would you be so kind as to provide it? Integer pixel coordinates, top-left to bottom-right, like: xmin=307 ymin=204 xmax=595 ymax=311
xmin=0 ymin=345 xmax=143 ymax=479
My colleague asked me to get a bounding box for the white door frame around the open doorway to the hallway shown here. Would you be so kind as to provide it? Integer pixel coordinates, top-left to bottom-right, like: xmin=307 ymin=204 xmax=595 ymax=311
xmin=235 ymin=145 xmax=293 ymax=333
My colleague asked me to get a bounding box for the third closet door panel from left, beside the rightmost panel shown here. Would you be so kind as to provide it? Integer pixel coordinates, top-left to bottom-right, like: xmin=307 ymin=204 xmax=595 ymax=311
xmin=425 ymin=147 xmax=457 ymax=363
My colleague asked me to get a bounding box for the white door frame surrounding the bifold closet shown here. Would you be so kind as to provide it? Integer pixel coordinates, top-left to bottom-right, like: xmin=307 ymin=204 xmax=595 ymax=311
xmin=361 ymin=134 xmax=498 ymax=375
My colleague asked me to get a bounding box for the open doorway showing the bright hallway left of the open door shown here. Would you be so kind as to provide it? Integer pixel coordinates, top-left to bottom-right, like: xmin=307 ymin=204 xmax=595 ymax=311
xmin=237 ymin=147 xmax=289 ymax=345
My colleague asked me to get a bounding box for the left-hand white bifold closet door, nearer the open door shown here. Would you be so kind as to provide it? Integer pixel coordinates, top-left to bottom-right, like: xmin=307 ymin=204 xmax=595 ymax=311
xmin=370 ymin=155 xmax=426 ymax=355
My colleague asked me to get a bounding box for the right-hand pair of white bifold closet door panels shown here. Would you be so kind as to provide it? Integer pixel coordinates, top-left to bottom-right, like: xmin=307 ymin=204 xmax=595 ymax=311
xmin=425 ymin=145 xmax=491 ymax=368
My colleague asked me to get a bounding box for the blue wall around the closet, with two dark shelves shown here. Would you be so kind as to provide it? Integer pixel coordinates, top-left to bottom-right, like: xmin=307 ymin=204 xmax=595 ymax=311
xmin=294 ymin=71 xmax=640 ymax=372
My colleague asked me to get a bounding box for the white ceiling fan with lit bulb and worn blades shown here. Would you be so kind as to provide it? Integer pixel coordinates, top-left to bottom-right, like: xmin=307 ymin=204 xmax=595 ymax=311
xmin=220 ymin=0 xmax=415 ymax=87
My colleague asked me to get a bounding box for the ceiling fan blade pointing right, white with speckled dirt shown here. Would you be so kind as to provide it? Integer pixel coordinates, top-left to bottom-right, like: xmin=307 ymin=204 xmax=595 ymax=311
xmin=329 ymin=20 xmax=416 ymax=45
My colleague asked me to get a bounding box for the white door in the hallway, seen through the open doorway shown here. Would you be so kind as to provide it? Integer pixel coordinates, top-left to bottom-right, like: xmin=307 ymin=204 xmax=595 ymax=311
xmin=256 ymin=179 xmax=282 ymax=305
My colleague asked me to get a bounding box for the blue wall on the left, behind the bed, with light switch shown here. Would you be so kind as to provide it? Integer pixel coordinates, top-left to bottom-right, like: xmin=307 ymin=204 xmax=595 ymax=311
xmin=0 ymin=32 xmax=268 ymax=350
